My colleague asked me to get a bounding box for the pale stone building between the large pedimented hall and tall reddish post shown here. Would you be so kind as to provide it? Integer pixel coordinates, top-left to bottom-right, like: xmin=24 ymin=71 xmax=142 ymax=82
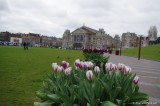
xmin=122 ymin=32 xmax=138 ymax=48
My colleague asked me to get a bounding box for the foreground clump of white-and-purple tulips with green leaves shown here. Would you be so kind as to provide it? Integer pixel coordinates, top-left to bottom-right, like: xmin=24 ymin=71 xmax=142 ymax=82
xmin=34 ymin=59 xmax=149 ymax=106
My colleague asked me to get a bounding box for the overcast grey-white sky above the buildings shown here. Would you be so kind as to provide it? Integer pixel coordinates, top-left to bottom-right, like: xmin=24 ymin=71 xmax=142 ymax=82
xmin=0 ymin=0 xmax=160 ymax=37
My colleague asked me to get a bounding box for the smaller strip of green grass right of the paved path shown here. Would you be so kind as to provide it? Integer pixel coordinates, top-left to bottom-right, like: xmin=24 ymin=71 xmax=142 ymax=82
xmin=122 ymin=45 xmax=160 ymax=60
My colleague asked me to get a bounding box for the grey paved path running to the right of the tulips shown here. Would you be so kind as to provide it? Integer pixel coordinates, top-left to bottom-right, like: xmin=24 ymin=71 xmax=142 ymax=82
xmin=105 ymin=54 xmax=160 ymax=106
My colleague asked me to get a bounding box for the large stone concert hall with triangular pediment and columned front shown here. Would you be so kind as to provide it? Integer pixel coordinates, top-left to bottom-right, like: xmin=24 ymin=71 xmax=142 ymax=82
xmin=62 ymin=26 xmax=117 ymax=49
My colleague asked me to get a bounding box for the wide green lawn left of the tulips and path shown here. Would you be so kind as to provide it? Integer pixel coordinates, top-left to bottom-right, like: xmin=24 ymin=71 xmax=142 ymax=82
xmin=0 ymin=46 xmax=84 ymax=106
